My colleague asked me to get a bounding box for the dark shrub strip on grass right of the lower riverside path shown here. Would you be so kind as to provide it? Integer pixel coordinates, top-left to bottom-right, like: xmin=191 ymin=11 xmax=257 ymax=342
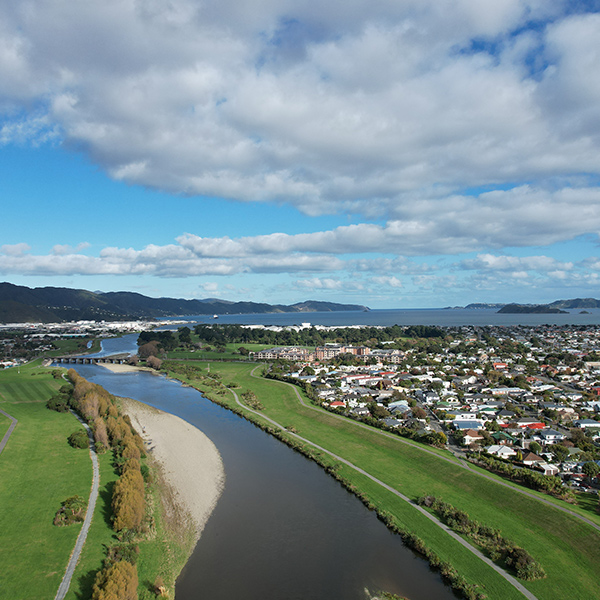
xmin=417 ymin=496 xmax=546 ymax=581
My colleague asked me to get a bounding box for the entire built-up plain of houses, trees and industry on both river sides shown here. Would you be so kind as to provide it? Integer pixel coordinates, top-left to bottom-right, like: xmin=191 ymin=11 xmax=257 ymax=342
xmin=0 ymin=321 xmax=600 ymax=502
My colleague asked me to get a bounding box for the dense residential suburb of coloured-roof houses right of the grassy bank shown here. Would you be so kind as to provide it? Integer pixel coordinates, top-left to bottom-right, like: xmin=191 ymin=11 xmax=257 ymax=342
xmin=240 ymin=326 xmax=600 ymax=500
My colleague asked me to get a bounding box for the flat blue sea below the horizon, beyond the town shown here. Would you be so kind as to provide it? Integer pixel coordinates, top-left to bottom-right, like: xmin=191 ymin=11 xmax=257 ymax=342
xmin=165 ymin=308 xmax=600 ymax=329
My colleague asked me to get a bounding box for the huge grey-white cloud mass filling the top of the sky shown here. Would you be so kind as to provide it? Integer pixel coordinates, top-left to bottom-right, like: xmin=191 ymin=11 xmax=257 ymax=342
xmin=0 ymin=0 xmax=600 ymax=223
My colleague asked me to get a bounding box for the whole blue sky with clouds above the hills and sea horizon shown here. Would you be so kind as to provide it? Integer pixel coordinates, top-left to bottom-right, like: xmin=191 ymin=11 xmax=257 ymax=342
xmin=0 ymin=0 xmax=600 ymax=308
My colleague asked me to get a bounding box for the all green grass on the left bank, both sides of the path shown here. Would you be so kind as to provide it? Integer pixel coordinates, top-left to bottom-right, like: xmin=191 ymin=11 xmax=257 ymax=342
xmin=0 ymin=361 xmax=200 ymax=600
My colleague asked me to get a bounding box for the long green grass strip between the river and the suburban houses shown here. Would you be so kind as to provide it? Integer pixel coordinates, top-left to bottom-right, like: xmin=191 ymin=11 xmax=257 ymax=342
xmin=166 ymin=363 xmax=600 ymax=600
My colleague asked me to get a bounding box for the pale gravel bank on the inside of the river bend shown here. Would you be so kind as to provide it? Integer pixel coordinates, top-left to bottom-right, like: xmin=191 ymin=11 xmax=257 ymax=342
xmin=119 ymin=398 xmax=225 ymax=539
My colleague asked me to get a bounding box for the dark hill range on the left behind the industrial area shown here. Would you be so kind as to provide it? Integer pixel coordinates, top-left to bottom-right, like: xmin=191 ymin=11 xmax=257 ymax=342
xmin=0 ymin=283 xmax=367 ymax=323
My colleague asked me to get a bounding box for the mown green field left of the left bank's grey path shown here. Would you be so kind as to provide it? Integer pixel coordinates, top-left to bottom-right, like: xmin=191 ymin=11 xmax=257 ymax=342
xmin=0 ymin=367 xmax=92 ymax=600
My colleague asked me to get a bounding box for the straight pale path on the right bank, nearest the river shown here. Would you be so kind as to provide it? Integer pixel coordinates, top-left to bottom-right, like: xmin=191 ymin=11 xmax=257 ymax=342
xmin=228 ymin=367 xmax=537 ymax=600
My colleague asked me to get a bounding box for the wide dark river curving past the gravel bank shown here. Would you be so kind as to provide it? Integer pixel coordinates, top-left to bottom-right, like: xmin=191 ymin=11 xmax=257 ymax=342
xmin=74 ymin=336 xmax=455 ymax=600
